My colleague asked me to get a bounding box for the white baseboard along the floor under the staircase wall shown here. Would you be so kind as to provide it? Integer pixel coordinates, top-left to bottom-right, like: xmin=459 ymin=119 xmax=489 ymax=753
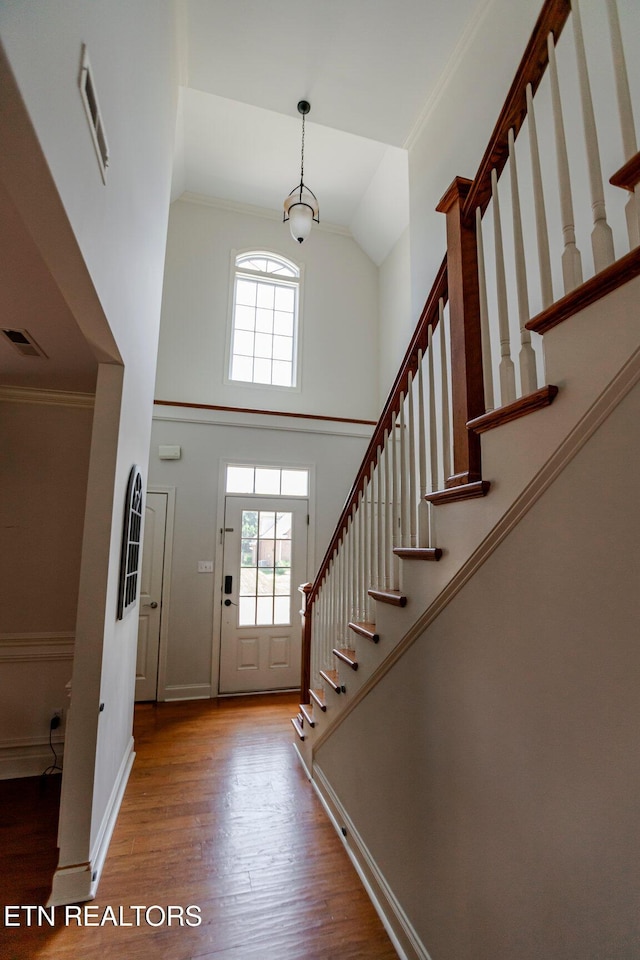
xmin=312 ymin=764 xmax=431 ymax=960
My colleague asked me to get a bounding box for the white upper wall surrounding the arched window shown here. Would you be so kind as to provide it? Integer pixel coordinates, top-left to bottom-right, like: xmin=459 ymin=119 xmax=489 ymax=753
xmin=156 ymin=200 xmax=379 ymax=420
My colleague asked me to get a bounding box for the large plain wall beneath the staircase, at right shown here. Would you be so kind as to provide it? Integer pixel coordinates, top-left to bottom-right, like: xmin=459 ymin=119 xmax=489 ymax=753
xmin=316 ymin=374 xmax=640 ymax=960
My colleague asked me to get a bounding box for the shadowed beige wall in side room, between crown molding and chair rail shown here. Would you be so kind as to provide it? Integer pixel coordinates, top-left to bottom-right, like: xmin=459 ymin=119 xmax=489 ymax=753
xmin=0 ymin=402 xmax=93 ymax=634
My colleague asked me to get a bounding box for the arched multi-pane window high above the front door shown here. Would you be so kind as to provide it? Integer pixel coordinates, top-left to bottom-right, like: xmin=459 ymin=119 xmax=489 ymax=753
xmin=229 ymin=250 xmax=301 ymax=387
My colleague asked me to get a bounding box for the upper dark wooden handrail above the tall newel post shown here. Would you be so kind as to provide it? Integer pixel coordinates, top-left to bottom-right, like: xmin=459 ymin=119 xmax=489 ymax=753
xmin=464 ymin=0 xmax=571 ymax=220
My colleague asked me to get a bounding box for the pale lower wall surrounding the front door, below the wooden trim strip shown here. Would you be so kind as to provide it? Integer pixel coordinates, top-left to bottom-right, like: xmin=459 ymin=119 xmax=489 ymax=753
xmin=149 ymin=407 xmax=369 ymax=699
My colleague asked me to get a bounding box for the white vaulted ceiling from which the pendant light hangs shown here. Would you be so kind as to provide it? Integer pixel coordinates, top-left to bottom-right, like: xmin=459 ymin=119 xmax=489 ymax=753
xmin=173 ymin=0 xmax=487 ymax=263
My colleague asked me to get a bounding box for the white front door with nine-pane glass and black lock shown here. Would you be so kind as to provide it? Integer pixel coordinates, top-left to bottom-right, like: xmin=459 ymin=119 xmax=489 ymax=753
xmin=220 ymin=496 xmax=308 ymax=693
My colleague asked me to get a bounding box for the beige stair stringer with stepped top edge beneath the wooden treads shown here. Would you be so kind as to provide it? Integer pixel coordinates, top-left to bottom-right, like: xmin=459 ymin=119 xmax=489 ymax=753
xmin=296 ymin=278 xmax=640 ymax=764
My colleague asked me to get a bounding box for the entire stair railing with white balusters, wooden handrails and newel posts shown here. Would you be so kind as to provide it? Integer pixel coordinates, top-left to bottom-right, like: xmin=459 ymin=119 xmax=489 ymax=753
xmin=302 ymin=0 xmax=640 ymax=696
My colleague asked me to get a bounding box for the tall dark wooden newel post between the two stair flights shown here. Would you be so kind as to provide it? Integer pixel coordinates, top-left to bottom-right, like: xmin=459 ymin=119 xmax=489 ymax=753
xmin=436 ymin=177 xmax=485 ymax=489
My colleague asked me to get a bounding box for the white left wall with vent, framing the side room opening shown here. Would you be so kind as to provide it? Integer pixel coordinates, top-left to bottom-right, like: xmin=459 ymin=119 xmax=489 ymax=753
xmin=0 ymin=0 xmax=175 ymax=902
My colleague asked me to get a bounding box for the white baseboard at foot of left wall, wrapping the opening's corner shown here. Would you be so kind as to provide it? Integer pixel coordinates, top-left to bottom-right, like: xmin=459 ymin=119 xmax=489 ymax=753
xmin=47 ymin=737 xmax=136 ymax=907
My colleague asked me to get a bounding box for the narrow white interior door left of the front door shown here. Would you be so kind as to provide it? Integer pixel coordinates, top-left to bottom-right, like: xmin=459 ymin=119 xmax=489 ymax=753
xmin=136 ymin=493 xmax=167 ymax=700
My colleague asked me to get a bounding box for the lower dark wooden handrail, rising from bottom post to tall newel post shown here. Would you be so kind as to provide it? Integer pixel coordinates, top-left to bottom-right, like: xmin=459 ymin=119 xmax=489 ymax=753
xmin=307 ymin=256 xmax=448 ymax=604
